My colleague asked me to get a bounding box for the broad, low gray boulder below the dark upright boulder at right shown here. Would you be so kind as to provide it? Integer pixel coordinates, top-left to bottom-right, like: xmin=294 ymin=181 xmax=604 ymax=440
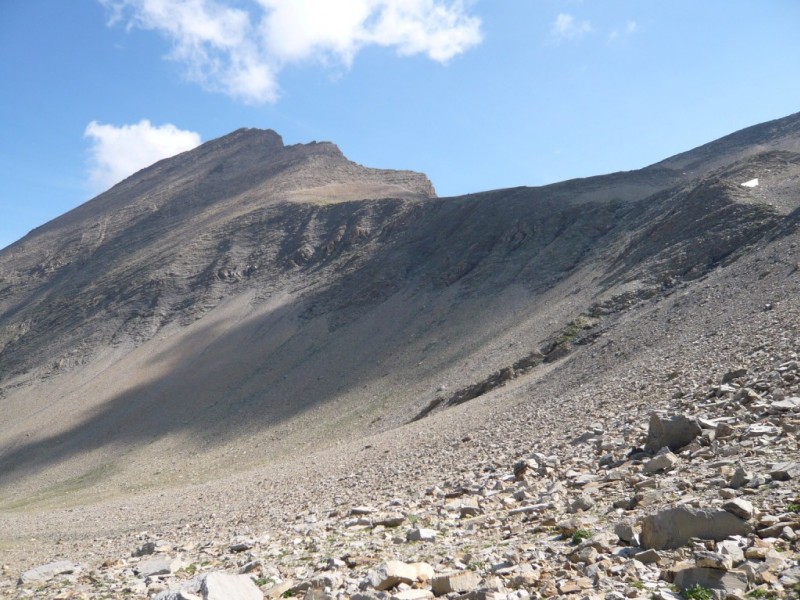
xmin=641 ymin=506 xmax=753 ymax=550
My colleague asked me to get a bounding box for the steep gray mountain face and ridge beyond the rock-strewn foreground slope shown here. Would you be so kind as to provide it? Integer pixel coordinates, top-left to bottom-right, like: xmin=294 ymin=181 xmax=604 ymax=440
xmin=0 ymin=115 xmax=800 ymax=506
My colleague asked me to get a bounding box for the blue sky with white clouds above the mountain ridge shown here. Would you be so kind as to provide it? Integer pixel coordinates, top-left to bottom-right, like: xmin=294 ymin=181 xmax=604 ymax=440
xmin=0 ymin=0 xmax=800 ymax=247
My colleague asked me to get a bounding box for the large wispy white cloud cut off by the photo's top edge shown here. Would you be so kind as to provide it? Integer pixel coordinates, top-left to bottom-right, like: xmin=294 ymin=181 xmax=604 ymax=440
xmin=99 ymin=0 xmax=481 ymax=104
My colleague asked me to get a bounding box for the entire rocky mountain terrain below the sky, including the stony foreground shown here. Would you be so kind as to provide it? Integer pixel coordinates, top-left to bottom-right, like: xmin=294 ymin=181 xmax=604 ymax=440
xmin=0 ymin=114 xmax=800 ymax=600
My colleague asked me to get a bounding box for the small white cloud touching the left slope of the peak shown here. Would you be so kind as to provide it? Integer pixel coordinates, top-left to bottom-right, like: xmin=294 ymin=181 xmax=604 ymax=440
xmin=83 ymin=119 xmax=200 ymax=191
